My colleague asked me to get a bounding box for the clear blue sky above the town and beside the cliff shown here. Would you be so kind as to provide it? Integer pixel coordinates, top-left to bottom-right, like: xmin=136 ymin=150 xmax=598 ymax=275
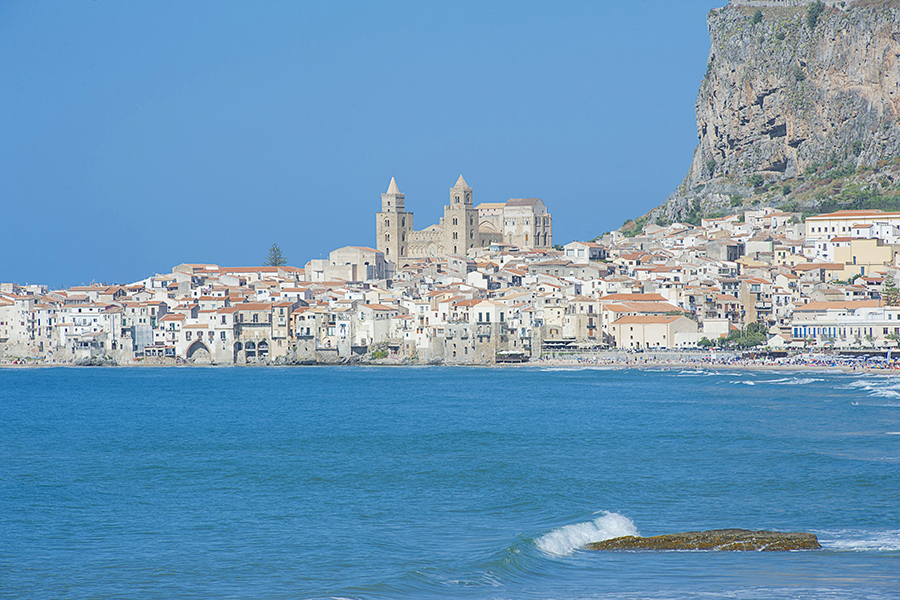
xmin=0 ymin=0 xmax=724 ymax=286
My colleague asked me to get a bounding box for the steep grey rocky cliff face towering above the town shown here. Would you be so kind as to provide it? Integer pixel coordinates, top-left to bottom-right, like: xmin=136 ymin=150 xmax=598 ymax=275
xmin=652 ymin=0 xmax=900 ymax=221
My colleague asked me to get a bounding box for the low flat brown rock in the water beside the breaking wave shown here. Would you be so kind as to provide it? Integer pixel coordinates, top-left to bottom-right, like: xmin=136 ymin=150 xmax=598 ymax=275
xmin=587 ymin=529 xmax=822 ymax=551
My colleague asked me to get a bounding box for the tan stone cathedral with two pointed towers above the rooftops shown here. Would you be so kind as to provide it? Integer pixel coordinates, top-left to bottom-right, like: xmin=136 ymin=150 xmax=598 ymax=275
xmin=375 ymin=175 xmax=553 ymax=264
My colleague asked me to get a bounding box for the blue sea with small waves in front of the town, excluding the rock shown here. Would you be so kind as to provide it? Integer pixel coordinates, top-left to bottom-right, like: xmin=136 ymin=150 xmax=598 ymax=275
xmin=0 ymin=367 xmax=900 ymax=600
